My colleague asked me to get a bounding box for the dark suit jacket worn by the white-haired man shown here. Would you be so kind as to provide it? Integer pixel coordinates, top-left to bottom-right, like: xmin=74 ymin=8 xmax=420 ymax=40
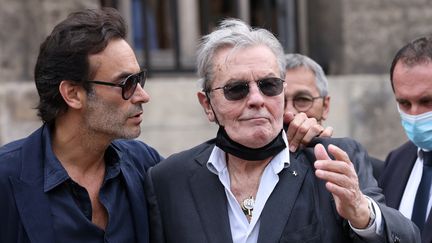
xmin=146 ymin=138 xmax=420 ymax=243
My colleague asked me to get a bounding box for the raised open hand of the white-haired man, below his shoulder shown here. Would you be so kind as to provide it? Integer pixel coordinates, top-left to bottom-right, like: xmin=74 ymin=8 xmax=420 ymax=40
xmin=314 ymin=144 xmax=370 ymax=229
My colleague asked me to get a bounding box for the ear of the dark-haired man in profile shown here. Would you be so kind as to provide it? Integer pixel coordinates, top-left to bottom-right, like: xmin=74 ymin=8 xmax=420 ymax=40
xmin=59 ymin=80 xmax=85 ymax=109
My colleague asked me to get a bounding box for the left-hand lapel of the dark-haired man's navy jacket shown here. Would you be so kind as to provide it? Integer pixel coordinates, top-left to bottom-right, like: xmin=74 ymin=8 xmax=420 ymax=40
xmin=9 ymin=126 xmax=54 ymax=243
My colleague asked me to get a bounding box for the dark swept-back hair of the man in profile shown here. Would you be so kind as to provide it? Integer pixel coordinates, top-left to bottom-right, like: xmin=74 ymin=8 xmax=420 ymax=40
xmin=34 ymin=8 xmax=127 ymax=124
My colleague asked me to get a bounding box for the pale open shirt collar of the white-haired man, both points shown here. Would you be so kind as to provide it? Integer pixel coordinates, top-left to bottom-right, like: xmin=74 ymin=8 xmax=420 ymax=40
xmin=207 ymin=132 xmax=290 ymax=175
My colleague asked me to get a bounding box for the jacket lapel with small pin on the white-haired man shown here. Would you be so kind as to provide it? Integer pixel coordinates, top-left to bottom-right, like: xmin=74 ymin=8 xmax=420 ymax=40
xmin=258 ymin=153 xmax=309 ymax=242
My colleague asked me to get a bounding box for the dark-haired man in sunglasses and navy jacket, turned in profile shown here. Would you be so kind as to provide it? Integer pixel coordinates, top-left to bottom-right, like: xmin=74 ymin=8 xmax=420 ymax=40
xmin=0 ymin=9 xmax=161 ymax=242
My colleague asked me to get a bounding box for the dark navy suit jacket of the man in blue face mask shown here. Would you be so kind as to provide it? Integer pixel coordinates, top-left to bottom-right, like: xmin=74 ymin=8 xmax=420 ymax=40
xmin=379 ymin=141 xmax=432 ymax=243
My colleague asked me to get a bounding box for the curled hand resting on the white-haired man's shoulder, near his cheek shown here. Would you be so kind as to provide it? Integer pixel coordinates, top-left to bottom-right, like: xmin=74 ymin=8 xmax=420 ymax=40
xmin=284 ymin=112 xmax=333 ymax=152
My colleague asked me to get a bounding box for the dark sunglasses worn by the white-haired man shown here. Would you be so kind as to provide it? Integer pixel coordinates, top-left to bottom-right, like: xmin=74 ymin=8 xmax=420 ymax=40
xmin=206 ymin=77 xmax=284 ymax=100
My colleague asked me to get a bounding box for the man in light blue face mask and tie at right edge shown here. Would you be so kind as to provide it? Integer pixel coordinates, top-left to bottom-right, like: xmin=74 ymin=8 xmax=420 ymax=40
xmin=379 ymin=36 xmax=432 ymax=243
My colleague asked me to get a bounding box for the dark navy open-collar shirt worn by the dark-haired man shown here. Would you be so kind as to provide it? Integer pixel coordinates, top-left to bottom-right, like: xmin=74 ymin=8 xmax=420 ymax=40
xmin=43 ymin=129 xmax=136 ymax=243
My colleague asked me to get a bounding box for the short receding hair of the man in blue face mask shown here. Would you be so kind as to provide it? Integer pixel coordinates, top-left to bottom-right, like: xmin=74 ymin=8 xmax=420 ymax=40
xmin=390 ymin=36 xmax=432 ymax=91
